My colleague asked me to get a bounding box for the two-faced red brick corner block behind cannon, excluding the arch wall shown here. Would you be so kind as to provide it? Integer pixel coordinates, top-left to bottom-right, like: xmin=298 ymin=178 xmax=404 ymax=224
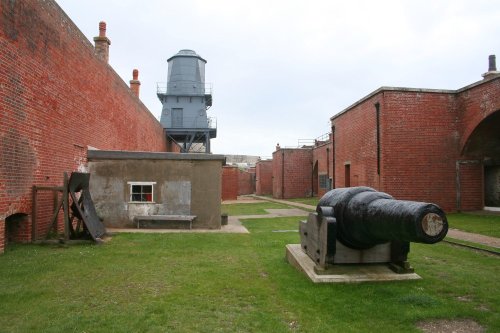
xmin=333 ymin=91 xmax=457 ymax=209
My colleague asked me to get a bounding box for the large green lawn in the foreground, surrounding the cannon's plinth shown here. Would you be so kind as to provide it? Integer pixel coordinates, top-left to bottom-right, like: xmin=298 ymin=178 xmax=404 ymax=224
xmin=0 ymin=218 xmax=500 ymax=332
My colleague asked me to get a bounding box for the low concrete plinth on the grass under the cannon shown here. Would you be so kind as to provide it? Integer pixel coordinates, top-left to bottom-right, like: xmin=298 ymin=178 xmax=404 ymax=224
xmin=286 ymin=244 xmax=421 ymax=283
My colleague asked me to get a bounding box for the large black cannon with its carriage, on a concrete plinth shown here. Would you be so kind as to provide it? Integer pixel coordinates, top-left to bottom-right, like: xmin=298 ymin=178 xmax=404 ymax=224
xmin=299 ymin=187 xmax=448 ymax=273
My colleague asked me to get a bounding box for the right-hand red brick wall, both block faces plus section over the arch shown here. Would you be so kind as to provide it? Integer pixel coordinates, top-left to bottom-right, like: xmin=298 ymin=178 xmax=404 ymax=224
xmin=332 ymin=79 xmax=500 ymax=211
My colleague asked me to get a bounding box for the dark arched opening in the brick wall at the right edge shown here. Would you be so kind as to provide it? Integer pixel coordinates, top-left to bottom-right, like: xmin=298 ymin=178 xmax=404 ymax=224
xmin=461 ymin=110 xmax=500 ymax=207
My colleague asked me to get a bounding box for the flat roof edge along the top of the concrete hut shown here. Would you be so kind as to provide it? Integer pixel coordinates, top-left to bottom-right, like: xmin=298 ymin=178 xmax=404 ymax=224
xmin=87 ymin=149 xmax=226 ymax=162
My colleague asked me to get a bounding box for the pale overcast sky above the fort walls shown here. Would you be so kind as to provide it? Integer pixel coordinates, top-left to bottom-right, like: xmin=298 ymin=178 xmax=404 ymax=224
xmin=57 ymin=0 xmax=500 ymax=157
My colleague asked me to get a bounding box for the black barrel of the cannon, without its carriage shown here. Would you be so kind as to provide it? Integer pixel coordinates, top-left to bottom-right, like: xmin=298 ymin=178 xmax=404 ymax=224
xmin=316 ymin=187 xmax=448 ymax=249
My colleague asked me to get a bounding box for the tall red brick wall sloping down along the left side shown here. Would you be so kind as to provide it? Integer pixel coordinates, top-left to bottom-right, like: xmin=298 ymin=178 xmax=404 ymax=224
xmin=0 ymin=0 xmax=166 ymax=249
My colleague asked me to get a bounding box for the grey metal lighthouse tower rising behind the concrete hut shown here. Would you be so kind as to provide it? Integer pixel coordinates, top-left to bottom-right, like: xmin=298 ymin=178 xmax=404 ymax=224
xmin=157 ymin=50 xmax=217 ymax=153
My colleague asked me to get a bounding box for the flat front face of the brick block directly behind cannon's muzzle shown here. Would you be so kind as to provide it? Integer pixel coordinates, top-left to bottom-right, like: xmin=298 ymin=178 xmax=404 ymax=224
xmin=381 ymin=91 xmax=458 ymax=210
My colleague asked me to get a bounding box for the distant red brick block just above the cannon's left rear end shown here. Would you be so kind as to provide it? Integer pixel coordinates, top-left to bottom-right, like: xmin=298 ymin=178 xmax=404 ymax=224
xmin=273 ymin=148 xmax=313 ymax=199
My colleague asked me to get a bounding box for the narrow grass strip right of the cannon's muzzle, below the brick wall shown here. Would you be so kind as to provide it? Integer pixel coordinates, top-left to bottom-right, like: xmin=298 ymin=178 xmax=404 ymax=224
xmin=447 ymin=213 xmax=500 ymax=237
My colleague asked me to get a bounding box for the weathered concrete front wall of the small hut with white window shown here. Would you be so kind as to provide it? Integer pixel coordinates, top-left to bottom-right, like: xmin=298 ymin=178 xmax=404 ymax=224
xmin=89 ymin=151 xmax=224 ymax=229
